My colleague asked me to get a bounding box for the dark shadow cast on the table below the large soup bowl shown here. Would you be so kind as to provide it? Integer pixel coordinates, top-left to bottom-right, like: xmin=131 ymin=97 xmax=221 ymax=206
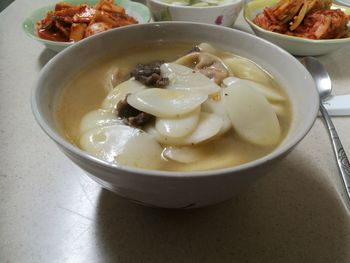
xmin=96 ymin=156 xmax=349 ymax=263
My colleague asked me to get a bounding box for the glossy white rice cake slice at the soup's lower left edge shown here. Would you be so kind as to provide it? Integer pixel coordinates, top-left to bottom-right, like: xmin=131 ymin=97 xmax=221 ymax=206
xmin=80 ymin=124 xmax=162 ymax=169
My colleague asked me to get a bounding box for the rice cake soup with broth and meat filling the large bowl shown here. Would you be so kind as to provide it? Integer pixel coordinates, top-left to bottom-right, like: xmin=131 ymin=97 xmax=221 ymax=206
xmin=57 ymin=43 xmax=291 ymax=171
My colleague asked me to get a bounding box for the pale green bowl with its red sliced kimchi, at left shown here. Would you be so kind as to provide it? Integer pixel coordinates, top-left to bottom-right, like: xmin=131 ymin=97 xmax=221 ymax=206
xmin=22 ymin=0 xmax=151 ymax=52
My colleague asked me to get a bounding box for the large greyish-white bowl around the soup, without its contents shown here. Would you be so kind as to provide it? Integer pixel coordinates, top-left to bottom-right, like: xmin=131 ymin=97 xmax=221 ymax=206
xmin=32 ymin=22 xmax=319 ymax=208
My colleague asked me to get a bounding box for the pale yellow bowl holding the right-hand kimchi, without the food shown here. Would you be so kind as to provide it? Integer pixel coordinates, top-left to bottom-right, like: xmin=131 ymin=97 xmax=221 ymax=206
xmin=243 ymin=0 xmax=350 ymax=56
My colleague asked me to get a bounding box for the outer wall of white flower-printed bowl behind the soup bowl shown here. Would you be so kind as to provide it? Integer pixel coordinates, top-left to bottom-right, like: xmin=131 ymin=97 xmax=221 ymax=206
xmin=147 ymin=0 xmax=244 ymax=27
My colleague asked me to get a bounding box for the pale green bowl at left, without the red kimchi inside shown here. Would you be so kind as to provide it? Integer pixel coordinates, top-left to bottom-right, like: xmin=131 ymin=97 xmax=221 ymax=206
xmin=22 ymin=0 xmax=151 ymax=52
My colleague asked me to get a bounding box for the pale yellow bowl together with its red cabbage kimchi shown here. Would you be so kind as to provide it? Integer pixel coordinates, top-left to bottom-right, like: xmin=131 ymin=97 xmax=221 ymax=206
xmin=243 ymin=0 xmax=350 ymax=56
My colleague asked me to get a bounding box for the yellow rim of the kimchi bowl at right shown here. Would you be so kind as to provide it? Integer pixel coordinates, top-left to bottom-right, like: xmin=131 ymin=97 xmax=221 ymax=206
xmin=243 ymin=0 xmax=350 ymax=45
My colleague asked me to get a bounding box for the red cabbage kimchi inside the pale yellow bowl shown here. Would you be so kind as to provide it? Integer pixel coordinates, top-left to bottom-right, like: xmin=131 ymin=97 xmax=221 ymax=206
xmin=253 ymin=0 xmax=350 ymax=39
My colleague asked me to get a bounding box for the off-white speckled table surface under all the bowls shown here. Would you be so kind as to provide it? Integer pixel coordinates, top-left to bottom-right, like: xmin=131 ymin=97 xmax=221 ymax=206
xmin=0 ymin=0 xmax=350 ymax=263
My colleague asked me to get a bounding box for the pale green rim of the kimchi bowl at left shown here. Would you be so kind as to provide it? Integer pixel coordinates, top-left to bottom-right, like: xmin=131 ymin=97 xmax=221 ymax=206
xmin=21 ymin=0 xmax=152 ymax=47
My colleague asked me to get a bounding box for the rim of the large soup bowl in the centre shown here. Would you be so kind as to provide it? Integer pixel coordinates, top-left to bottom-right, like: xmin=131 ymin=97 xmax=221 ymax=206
xmin=31 ymin=21 xmax=319 ymax=179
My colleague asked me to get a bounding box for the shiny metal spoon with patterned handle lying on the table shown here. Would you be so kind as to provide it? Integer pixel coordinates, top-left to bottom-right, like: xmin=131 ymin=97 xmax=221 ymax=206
xmin=301 ymin=57 xmax=350 ymax=209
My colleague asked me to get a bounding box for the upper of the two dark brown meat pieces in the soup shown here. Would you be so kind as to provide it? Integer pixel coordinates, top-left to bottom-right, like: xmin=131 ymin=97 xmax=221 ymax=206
xmin=130 ymin=61 xmax=169 ymax=88
